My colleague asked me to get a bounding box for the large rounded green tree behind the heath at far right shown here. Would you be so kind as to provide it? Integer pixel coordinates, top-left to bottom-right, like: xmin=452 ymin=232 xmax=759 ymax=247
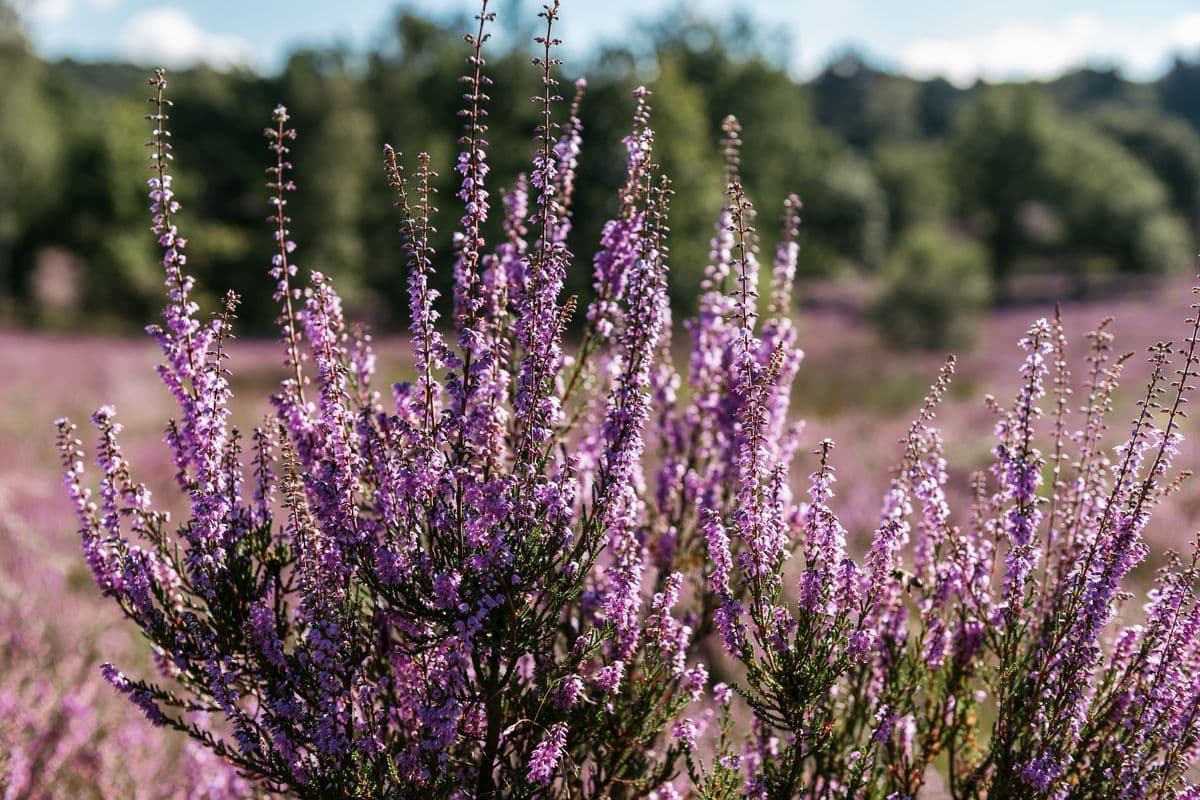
xmin=949 ymin=86 xmax=1188 ymax=289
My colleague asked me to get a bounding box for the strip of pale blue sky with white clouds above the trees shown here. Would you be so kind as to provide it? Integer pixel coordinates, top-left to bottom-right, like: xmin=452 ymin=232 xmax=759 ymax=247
xmin=18 ymin=0 xmax=1200 ymax=83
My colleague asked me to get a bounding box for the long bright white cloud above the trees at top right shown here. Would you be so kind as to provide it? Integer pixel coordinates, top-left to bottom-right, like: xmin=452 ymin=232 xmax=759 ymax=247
xmin=899 ymin=13 xmax=1200 ymax=85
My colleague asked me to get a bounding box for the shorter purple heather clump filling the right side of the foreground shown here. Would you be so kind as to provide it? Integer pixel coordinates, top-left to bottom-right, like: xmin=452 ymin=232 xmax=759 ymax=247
xmin=668 ymin=227 xmax=1200 ymax=799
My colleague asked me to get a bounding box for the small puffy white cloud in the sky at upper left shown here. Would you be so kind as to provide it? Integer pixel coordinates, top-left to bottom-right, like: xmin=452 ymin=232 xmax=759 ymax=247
xmin=120 ymin=7 xmax=254 ymax=67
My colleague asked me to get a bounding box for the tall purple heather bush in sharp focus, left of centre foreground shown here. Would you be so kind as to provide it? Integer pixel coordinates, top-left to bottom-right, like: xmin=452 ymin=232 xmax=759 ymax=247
xmin=60 ymin=4 xmax=707 ymax=798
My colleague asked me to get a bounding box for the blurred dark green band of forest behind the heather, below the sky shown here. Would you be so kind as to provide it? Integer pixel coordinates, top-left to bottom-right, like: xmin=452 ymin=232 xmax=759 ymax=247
xmin=0 ymin=6 xmax=1200 ymax=345
